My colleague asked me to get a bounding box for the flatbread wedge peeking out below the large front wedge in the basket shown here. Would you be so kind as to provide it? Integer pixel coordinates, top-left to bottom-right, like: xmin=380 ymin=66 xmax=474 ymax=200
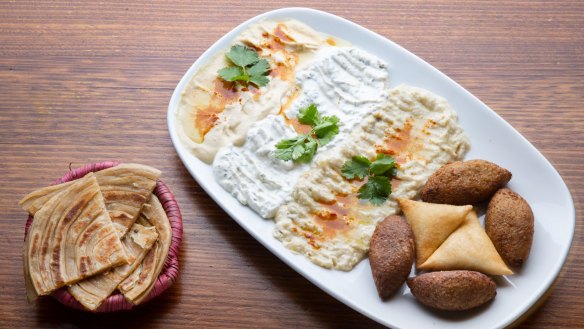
xmin=68 ymin=224 xmax=158 ymax=311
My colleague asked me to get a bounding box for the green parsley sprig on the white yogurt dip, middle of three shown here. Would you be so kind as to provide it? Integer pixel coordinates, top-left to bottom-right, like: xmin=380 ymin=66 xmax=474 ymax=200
xmin=276 ymin=104 xmax=339 ymax=162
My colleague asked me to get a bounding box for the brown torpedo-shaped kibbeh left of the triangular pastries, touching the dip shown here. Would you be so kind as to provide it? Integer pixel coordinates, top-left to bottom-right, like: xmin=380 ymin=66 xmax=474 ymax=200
xmin=369 ymin=215 xmax=414 ymax=299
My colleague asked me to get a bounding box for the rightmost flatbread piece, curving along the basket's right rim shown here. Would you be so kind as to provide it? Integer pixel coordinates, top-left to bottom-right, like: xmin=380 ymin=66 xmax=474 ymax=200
xmin=118 ymin=195 xmax=172 ymax=304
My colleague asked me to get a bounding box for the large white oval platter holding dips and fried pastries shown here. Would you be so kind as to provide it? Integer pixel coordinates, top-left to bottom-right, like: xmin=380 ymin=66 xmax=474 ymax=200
xmin=168 ymin=8 xmax=575 ymax=328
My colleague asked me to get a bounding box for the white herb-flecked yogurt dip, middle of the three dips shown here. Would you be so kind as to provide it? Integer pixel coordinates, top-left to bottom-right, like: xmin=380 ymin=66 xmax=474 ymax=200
xmin=213 ymin=47 xmax=389 ymax=218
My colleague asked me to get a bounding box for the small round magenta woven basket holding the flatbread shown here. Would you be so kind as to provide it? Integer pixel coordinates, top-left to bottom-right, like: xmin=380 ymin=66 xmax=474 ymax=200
xmin=24 ymin=161 xmax=183 ymax=313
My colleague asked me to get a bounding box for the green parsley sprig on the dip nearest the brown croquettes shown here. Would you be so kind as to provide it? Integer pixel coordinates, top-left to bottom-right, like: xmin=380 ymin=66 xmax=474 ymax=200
xmin=341 ymin=154 xmax=397 ymax=206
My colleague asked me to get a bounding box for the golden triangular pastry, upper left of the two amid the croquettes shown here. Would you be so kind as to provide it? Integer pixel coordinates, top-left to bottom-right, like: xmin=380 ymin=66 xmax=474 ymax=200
xmin=397 ymin=198 xmax=472 ymax=268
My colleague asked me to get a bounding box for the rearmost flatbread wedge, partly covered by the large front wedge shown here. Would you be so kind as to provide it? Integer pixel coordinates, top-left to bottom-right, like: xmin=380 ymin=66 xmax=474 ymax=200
xmin=19 ymin=163 xmax=160 ymax=236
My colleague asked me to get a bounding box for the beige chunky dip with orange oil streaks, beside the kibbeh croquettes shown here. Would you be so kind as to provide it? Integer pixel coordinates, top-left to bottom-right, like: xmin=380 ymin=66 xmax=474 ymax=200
xmin=274 ymin=85 xmax=469 ymax=271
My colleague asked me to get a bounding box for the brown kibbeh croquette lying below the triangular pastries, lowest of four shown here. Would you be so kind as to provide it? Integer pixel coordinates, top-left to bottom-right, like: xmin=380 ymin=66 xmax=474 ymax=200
xmin=407 ymin=271 xmax=497 ymax=311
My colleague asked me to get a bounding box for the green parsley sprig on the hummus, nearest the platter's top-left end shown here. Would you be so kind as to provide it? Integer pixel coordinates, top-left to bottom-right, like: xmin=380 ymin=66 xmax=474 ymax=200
xmin=217 ymin=45 xmax=270 ymax=87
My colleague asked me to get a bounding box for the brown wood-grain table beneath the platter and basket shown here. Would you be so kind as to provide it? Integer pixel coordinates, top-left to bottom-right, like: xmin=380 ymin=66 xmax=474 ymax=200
xmin=0 ymin=0 xmax=584 ymax=328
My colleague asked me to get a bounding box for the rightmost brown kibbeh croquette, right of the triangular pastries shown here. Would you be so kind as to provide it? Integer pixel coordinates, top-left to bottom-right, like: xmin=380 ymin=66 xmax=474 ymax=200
xmin=485 ymin=188 xmax=534 ymax=266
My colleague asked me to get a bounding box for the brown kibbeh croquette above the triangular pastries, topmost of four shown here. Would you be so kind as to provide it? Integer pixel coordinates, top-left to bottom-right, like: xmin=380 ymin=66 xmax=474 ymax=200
xmin=421 ymin=160 xmax=511 ymax=205
